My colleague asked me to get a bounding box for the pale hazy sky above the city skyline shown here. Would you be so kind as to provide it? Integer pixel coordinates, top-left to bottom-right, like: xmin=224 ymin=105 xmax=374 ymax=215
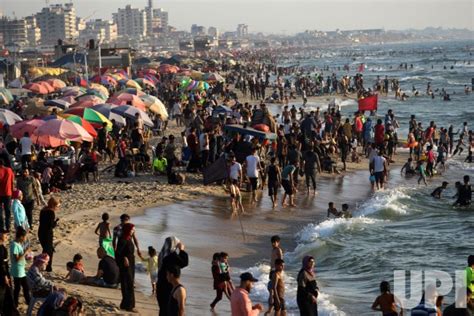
xmin=0 ymin=0 xmax=474 ymax=34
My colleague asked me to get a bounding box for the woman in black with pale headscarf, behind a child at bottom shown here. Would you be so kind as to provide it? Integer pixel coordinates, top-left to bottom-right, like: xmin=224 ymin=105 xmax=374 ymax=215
xmin=156 ymin=236 xmax=189 ymax=316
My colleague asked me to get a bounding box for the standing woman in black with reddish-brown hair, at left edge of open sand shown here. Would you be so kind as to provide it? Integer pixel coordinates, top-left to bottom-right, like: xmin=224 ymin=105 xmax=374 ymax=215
xmin=38 ymin=197 xmax=61 ymax=272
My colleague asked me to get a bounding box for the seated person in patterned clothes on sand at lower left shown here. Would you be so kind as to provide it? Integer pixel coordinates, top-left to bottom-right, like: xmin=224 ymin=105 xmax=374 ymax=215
xmin=26 ymin=253 xmax=56 ymax=297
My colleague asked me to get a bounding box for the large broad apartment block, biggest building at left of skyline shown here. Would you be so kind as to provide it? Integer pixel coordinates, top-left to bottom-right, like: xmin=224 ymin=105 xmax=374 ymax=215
xmin=36 ymin=3 xmax=79 ymax=44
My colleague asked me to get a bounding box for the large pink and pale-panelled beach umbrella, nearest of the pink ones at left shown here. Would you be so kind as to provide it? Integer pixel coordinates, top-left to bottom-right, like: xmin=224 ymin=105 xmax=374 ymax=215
xmin=31 ymin=119 xmax=94 ymax=147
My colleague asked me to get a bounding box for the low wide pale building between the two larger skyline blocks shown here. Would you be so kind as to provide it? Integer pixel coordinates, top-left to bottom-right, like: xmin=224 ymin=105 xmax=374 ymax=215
xmin=79 ymin=19 xmax=118 ymax=44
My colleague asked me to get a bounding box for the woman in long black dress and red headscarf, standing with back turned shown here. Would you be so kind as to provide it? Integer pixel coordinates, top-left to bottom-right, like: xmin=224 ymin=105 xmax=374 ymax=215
xmin=115 ymin=223 xmax=137 ymax=313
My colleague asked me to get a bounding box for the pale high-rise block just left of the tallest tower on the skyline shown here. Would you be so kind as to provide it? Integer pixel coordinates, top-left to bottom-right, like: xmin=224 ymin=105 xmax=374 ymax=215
xmin=113 ymin=5 xmax=147 ymax=39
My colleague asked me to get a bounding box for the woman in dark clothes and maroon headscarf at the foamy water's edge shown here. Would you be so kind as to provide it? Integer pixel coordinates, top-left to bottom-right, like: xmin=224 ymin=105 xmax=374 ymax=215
xmin=296 ymin=256 xmax=319 ymax=316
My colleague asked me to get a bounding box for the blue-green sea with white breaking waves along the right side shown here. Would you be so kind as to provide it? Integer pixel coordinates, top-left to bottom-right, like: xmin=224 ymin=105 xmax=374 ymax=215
xmin=137 ymin=41 xmax=474 ymax=315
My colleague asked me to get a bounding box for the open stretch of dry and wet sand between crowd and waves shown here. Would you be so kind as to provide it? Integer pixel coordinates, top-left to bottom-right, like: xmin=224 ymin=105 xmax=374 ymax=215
xmin=11 ymin=98 xmax=406 ymax=315
